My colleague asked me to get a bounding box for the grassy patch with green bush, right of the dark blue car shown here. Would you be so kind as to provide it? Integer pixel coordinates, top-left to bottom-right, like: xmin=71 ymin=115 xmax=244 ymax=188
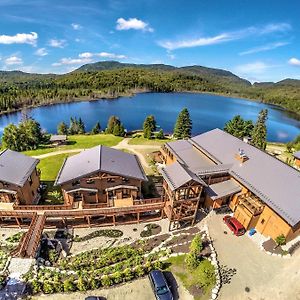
xmin=168 ymin=255 xmax=216 ymax=300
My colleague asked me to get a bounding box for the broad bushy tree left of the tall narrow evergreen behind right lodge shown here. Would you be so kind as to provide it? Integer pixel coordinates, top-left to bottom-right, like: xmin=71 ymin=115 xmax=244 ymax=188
xmin=224 ymin=115 xmax=254 ymax=139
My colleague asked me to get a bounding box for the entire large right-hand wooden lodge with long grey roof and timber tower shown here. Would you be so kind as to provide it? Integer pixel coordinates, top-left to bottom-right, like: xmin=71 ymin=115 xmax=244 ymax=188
xmin=161 ymin=129 xmax=300 ymax=241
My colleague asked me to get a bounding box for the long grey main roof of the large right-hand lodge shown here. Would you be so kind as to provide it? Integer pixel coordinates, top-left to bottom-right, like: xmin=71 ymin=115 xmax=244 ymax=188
xmin=191 ymin=129 xmax=300 ymax=226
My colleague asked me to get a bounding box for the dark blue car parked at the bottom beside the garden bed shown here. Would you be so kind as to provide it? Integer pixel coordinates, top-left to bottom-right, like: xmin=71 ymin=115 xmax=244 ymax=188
xmin=149 ymin=270 xmax=173 ymax=300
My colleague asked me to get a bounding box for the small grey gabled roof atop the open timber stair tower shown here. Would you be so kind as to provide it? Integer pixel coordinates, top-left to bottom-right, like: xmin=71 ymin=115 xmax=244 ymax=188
xmin=161 ymin=161 xmax=206 ymax=191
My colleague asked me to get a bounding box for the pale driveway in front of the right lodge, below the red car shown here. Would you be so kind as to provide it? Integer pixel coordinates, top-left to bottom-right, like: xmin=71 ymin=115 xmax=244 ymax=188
xmin=208 ymin=215 xmax=300 ymax=300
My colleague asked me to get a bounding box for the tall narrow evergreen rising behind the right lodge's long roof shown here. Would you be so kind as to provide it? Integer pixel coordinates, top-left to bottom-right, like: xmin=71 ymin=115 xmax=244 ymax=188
xmin=251 ymin=109 xmax=268 ymax=150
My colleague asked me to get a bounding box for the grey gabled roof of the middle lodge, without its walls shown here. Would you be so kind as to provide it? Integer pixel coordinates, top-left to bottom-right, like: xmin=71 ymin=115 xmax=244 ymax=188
xmin=55 ymin=145 xmax=147 ymax=185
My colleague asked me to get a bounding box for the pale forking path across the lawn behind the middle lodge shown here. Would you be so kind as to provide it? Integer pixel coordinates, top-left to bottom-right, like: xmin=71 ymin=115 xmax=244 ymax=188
xmin=33 ymin=138 xmax=161 ymax=168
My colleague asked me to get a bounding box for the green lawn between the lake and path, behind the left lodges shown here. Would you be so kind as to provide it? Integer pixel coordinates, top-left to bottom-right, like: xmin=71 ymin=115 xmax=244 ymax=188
xmin=23 ymin=134 xmax=123 ymax=156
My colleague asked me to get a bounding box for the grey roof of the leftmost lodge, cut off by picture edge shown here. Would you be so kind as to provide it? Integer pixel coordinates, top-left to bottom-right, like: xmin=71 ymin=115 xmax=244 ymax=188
xmin=0 ymin=149 xmax=39 ymax=186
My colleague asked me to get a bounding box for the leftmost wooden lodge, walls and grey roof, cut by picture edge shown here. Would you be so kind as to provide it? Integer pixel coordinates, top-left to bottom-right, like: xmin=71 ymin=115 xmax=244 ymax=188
xmin=0 ymin=149 xmax=40 ymax=208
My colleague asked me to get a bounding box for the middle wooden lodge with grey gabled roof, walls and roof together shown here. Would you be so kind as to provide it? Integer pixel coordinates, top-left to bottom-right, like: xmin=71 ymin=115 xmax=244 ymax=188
xmin=56 ymin=146 xmax=147 ymax=207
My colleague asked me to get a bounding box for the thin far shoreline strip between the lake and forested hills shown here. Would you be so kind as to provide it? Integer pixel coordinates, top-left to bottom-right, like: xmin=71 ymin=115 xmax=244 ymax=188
xmin=0 ymin=89 xmax=300 ymax=120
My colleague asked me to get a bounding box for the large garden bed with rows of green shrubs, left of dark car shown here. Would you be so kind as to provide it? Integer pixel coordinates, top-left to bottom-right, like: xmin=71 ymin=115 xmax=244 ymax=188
xmin=24 ymin=246 xmax=166 ymax=294
